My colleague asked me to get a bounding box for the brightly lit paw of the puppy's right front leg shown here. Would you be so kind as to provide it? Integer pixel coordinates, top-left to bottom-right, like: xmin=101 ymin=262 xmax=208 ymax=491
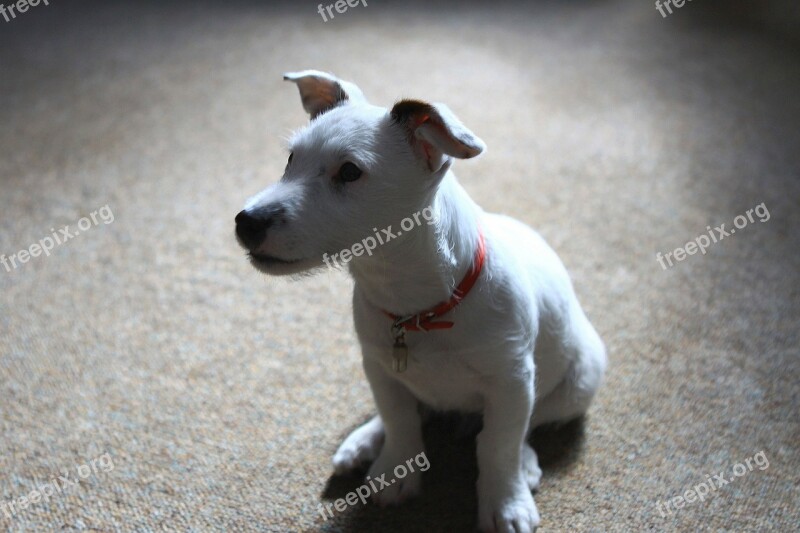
xmin=478 ymin=483 xmax=539 ymax=533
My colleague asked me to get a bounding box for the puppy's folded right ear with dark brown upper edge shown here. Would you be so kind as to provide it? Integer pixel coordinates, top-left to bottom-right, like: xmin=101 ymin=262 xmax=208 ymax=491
xmin=391 ymin=100 xmax=486 ymax=172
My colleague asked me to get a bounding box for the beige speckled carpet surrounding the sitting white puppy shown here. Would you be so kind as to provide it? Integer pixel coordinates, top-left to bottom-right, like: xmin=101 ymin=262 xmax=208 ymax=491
xmin=0 ymin=0 xmax=800 ymax=532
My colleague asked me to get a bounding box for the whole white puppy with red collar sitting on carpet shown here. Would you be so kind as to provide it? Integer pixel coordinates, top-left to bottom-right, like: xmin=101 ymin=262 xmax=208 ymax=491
xmin=236 ymin=71 xmax=606 ymax=532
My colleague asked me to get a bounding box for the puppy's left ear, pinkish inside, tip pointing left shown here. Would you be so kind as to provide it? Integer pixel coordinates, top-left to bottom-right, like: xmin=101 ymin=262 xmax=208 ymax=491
xmin=283 ymin=70 xmax=367 ymax=119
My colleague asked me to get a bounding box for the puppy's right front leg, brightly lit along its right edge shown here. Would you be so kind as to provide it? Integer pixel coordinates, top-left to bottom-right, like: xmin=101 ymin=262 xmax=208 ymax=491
xmin=477 ymin=379 xmax=539 ymax=533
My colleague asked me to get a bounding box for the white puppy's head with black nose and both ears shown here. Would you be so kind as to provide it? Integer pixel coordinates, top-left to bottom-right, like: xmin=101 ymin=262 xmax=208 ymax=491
xmin=236 ymin=71 xmax=484 ymax=275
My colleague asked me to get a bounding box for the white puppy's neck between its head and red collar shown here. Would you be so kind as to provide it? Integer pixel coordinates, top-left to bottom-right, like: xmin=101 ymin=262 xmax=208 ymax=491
xmin=350 ymin=171 xmax=481 ymax=315
